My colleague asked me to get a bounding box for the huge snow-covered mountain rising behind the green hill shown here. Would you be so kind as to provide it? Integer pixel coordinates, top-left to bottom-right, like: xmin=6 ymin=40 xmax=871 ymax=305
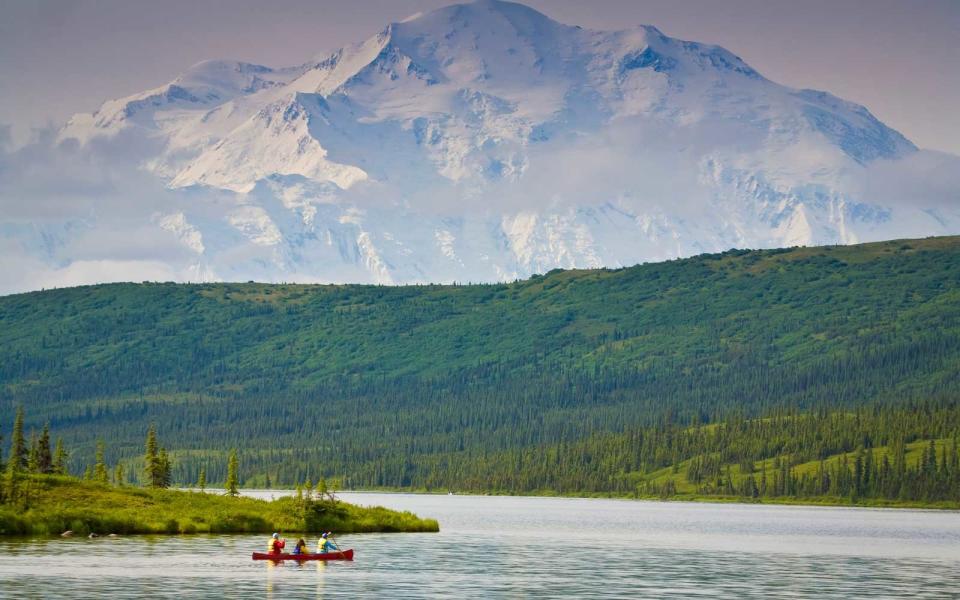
xmin=26 ymin=0 xmax=960 ymax=283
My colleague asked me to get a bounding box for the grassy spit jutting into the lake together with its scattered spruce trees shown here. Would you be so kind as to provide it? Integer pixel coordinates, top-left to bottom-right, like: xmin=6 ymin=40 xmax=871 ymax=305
xmin=0 ymin=410 xmax=440 ymax=535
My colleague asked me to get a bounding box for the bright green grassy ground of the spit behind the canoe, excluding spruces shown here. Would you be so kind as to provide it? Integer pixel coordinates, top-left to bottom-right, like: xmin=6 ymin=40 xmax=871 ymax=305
xmin=0 ymin=475 xmax=440 ymax=535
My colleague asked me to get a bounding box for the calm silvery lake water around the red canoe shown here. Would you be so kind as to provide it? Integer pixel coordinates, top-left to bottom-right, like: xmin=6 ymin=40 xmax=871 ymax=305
xmin=0 ymin=493 xmax=960 ymax=599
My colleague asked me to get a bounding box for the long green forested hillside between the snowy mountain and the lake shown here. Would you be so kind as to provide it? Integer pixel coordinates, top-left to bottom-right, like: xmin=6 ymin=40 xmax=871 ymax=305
xmin=0 ymin=237 xmax=960 ymax=498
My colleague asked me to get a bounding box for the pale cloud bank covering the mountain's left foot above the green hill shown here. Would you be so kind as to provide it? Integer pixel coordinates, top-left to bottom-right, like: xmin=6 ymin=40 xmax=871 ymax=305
xmin=0 ymin=122 xmax=209 ymax=293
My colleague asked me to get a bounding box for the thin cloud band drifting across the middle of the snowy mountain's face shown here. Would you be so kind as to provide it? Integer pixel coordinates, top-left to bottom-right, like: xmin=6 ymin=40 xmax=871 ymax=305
xmin=341 ymin=117 xmax=760 ymax=218
